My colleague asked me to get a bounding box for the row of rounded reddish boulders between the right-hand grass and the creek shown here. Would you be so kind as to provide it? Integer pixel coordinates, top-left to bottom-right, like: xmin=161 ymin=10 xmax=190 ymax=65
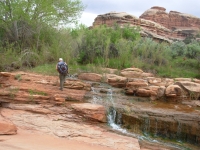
xmin=77 ymin=68 xmax=200 ymax=102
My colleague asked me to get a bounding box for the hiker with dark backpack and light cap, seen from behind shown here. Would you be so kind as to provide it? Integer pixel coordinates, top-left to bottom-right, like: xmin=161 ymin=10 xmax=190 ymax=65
xmin=56 ymin=58 xmax=68 ymax=91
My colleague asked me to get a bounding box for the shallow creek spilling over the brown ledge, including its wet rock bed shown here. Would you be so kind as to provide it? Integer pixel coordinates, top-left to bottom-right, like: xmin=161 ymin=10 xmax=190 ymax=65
xmin=87 ymin=83 xmax=200 ymax=150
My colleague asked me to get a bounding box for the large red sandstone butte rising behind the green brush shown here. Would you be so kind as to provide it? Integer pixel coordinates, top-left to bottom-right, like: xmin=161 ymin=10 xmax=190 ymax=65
xmin=92 ymin=6 xmax=200 ymax=42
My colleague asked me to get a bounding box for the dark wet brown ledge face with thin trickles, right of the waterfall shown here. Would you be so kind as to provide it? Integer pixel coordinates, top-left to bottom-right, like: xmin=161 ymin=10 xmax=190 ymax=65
xmin=119 ymin=107 xmax=200 ymax=145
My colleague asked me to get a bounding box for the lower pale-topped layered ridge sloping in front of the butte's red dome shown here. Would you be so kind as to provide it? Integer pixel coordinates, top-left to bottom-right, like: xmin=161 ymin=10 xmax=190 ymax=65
xmin=93 ymin=12 xmax=172 ymax=42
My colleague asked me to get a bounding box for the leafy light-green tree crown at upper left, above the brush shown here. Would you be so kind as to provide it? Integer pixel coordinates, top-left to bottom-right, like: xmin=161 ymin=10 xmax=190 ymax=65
xmin=0 ymin=0 xmax=84 ymax=47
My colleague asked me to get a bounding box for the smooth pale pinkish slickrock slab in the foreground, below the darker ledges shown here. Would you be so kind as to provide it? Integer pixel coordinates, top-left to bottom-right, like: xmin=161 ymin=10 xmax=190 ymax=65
xmin=0 ymin=108 xmax=140 ymax=150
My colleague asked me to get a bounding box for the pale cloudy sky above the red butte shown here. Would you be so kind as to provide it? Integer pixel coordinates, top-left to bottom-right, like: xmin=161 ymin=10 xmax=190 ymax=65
xmin=79 ymin=0 xmax=200 ymax=27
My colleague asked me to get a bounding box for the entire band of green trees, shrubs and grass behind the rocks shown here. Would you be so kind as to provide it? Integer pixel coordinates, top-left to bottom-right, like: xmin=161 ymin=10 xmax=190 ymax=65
xmin=0 ymin=0 xmax=200 ymax=78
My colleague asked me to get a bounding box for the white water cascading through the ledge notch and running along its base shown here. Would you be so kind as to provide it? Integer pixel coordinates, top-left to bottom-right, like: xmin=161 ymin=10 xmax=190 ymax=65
xmin=91 ymin=87 xmax=195 ymax=150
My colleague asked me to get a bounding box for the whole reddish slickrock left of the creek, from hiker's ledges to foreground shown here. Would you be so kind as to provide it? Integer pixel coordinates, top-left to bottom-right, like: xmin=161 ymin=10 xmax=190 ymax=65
xmin=0 ymin=72 xmax=140 ymax=150
